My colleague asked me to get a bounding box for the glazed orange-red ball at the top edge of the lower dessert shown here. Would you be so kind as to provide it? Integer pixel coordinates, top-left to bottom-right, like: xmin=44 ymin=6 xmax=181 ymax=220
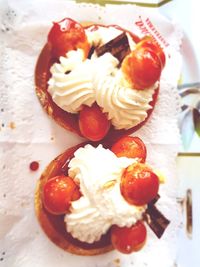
xmin=111 ymin=136 xmax=147 ymax=162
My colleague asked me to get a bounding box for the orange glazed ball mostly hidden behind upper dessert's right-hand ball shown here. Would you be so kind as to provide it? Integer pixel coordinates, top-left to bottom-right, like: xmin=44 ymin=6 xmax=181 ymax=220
xmin=136 ymin=35 xmax=166 ymax=68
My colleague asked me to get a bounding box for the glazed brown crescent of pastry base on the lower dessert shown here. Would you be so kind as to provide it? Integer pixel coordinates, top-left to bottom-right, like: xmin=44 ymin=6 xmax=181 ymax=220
xmin=35 ymin=143 xmax=113 ymax=256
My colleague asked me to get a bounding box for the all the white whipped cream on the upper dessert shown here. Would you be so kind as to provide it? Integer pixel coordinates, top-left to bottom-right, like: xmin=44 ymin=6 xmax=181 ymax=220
xmin=48 ymin=24 xmax=158 ymax=129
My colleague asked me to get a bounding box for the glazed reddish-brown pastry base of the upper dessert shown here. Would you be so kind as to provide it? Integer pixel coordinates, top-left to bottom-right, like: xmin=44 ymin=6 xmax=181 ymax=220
xmin=35 ymin=23 xmax=159 ymax=143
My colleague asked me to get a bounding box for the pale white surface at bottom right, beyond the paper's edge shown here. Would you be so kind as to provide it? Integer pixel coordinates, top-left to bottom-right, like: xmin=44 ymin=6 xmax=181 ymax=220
xmin=177 ymin=156 xmax=200 ymax=267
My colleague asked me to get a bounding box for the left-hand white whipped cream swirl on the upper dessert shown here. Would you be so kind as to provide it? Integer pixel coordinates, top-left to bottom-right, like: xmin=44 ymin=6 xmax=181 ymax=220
xmin=48 ymin=49 xmax=95 ymax=113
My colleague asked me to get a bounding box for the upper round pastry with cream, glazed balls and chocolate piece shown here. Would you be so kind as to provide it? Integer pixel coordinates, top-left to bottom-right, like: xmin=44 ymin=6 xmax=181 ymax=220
xmin=35 ymin=18 xmax=165 ymax=141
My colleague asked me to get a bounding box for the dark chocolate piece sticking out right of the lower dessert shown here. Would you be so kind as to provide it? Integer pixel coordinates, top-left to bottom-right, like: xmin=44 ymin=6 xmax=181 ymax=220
xmin=144 ymin=204 xmax=170 ymax=238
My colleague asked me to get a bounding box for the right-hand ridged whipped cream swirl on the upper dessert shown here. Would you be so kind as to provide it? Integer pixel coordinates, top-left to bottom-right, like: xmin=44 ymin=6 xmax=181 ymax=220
xmin=95 ymin=72 xmax=158 ymax=129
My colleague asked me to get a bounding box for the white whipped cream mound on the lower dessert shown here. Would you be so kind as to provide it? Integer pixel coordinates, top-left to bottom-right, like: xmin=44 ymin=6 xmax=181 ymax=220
xmin=65 ymin=145 xmax=146 ymax=243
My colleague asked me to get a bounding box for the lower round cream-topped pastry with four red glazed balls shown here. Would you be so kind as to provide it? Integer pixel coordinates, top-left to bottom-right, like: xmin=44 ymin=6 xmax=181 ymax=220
xmin=35 ymin=136 xmax=169 ymax=255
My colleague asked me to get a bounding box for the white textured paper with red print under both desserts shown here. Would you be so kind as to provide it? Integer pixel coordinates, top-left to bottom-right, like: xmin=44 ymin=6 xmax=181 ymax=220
xmin=0 ymin=0 xmax=181 ymax=267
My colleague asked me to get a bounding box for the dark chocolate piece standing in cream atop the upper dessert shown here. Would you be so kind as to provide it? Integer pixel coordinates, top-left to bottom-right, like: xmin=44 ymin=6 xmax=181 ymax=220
xmin=95 ymin=32 xmax=130 ymax=62
